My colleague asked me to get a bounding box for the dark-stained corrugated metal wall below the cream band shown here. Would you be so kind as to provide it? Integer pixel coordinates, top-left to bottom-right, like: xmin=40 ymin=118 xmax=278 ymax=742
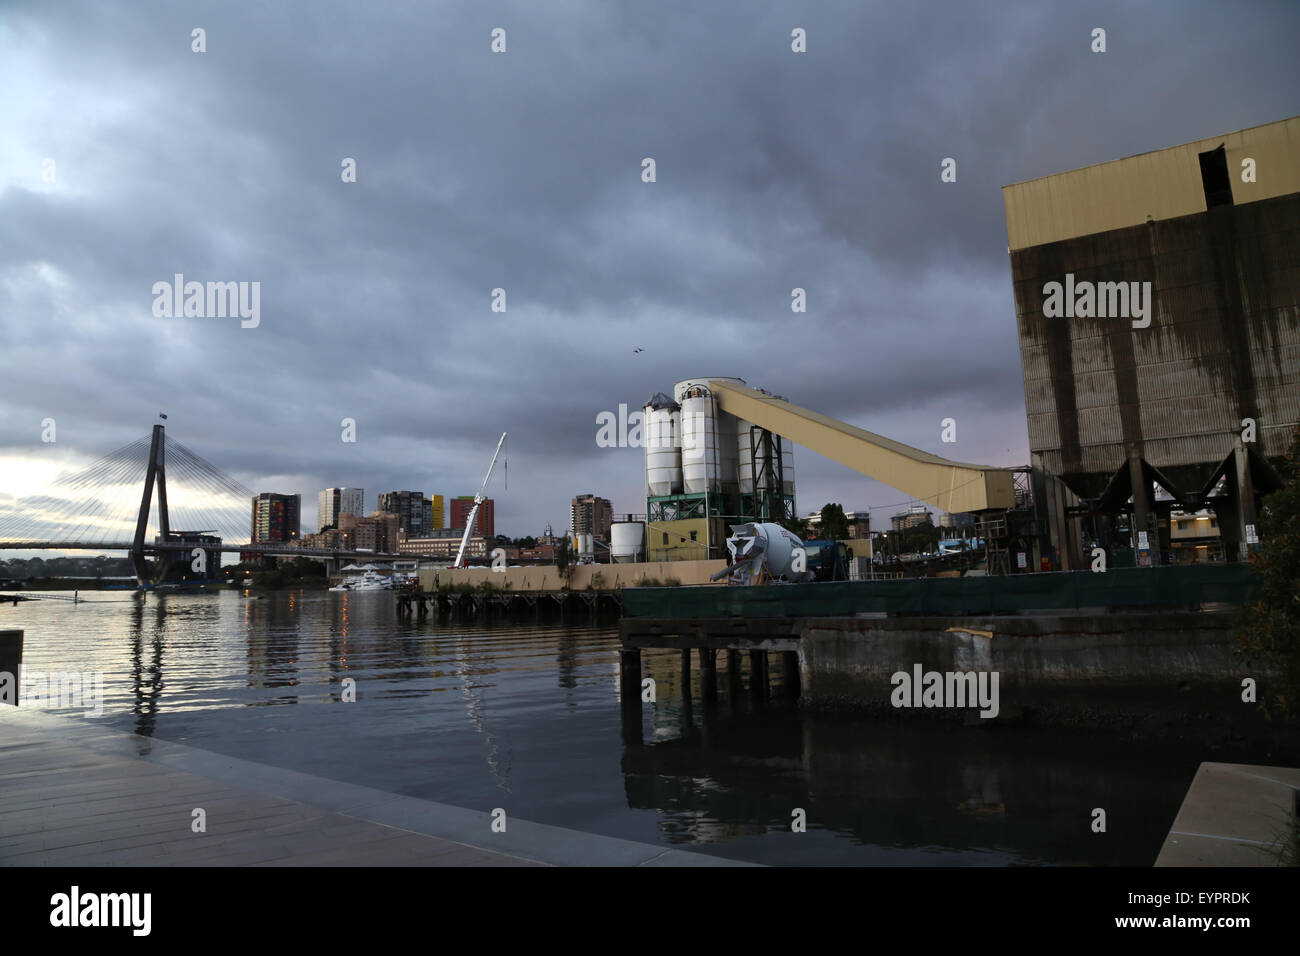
xmin=1011 ymin=191 xmax=1300 ymax=497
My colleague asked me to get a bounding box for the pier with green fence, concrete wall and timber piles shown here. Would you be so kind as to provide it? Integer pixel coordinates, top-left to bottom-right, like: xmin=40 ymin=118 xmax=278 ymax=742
xmin=619 ymin=566 xmax=1255 ymax=726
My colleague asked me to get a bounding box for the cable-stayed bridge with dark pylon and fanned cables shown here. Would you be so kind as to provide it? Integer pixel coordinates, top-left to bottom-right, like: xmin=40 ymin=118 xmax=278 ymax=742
xmin=0 ymin=424 xmax=412 ymax=585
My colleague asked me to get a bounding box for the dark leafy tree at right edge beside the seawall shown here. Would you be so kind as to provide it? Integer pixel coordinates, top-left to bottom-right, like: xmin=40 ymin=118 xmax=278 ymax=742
xmin=1238 ymin=428 xmax=1300 ymax=718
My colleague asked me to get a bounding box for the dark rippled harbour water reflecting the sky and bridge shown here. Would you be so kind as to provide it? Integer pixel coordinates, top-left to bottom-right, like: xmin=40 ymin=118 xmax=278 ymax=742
xmin=0 ymin=592 xmax=1263 ymax=866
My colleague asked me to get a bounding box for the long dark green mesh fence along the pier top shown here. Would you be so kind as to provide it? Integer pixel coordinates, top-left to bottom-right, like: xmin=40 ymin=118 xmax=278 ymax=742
xmin=623 ymin=564 xmax=1251 ymax=618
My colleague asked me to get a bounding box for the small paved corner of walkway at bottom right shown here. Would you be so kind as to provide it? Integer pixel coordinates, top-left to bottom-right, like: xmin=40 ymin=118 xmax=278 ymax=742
xmin=1156 ymin=762 xmax=1300 ymax=866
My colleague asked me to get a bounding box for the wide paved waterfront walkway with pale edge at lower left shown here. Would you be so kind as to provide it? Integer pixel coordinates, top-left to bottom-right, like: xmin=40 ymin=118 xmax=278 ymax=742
xmin=0 ymin=706 xmax=754 ymax=866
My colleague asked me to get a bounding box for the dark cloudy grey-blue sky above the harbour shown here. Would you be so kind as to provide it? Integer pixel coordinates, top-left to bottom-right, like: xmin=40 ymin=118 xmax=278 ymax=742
xmin=0 ymin=0 xmax=1300 ymax=535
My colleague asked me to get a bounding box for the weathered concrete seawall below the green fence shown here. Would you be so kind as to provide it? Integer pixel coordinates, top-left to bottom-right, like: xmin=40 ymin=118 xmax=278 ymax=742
xmin=794 ymin=613 xmax=1266 ymax=721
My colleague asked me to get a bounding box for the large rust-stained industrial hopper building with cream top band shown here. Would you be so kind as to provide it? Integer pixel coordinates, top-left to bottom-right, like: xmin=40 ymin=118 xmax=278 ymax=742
xmin=1002 ymin=117 xmax=1300 ymax=568
